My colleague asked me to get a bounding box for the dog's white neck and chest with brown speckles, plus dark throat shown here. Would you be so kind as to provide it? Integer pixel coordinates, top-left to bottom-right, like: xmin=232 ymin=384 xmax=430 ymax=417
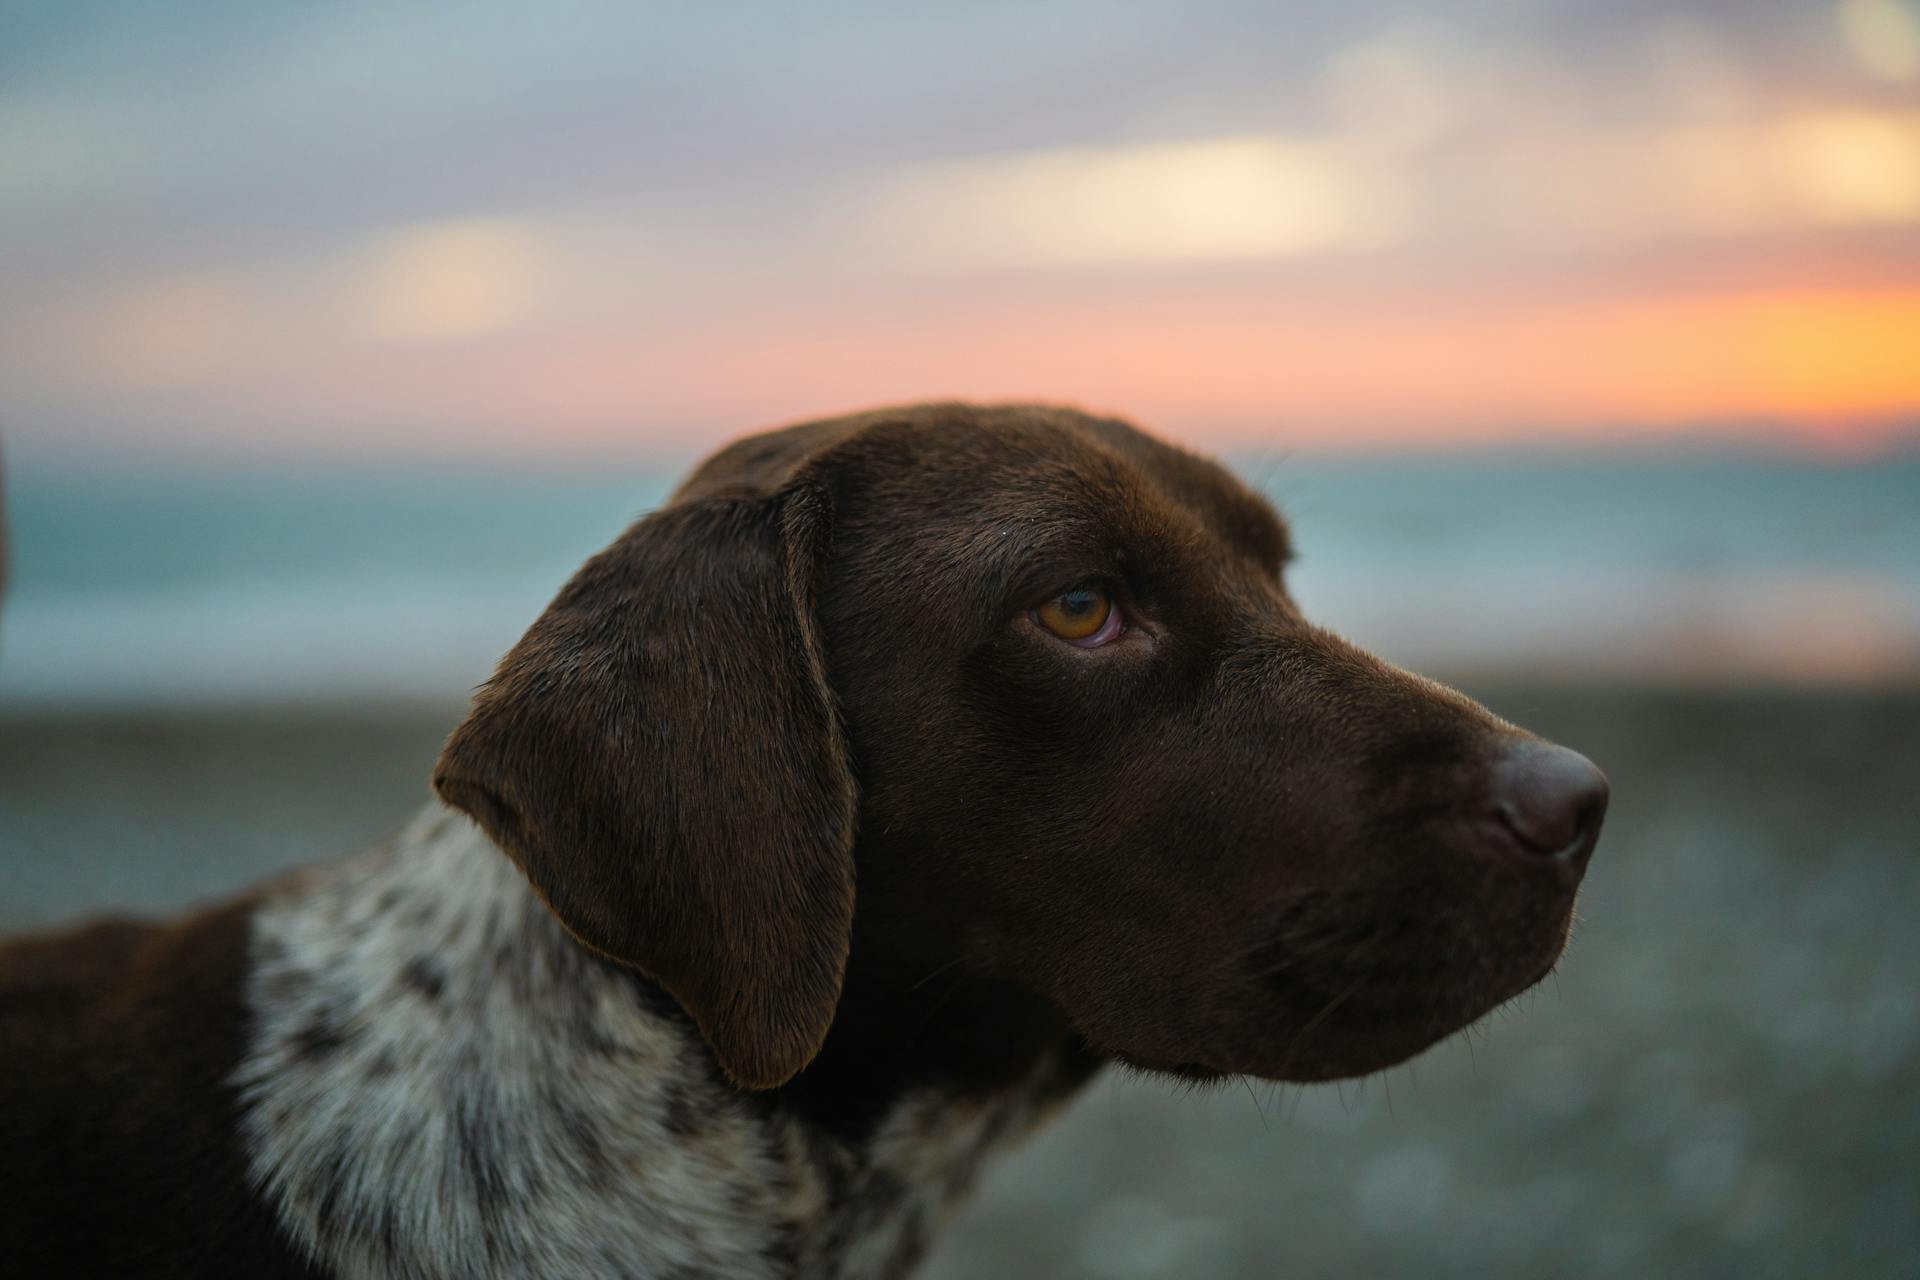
xmin=236 ymin=806 xmax=1094 ymax=1278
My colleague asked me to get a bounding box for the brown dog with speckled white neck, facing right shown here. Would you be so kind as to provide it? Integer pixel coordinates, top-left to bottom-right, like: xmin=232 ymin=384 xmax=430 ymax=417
xmin=0 ymin=405 xmax=1607 ymax=1280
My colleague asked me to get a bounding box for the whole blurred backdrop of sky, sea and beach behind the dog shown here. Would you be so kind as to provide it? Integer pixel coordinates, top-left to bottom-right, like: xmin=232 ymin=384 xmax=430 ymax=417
xmin=0 ymin=0 xmax=1920 ymax=1280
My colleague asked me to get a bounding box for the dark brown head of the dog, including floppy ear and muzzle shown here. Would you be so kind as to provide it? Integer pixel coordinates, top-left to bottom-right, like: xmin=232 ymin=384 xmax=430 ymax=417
xmin=434 ymin=407 xmax=1607 ymax=1088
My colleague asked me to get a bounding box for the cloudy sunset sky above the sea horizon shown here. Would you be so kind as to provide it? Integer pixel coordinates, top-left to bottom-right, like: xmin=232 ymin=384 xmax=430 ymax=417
xmin=0 ymin=0 xmax=1920 ymax=459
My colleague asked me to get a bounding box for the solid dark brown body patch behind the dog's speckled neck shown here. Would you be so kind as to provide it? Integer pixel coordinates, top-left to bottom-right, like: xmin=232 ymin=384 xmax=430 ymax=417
xmin=0 ymin=898 xmax=317 ymax=1276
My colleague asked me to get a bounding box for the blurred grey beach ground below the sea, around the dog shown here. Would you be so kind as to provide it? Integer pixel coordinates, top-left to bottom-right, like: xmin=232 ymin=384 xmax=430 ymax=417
xmin=0 ymin=687 xmax=1920 ymax=1280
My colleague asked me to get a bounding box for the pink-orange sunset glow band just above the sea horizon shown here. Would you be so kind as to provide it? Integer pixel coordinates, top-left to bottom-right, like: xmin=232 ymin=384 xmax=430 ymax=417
xmin=45 ymin=286 xmax=1920 ymax=453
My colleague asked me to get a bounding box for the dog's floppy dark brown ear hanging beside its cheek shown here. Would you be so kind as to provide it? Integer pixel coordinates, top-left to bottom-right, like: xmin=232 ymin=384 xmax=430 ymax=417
xmin=434 ymin=487 xmax=854 ymax=1088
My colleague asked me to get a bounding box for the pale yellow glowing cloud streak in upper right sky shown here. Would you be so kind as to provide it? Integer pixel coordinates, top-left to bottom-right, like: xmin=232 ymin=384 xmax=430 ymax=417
xmin=860 ymin=104 xmax=1920 ymax=274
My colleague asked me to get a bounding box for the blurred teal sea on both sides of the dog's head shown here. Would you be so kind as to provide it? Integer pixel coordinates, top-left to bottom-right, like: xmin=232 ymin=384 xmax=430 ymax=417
xmin=0 ymin=451 xmax=1920 ymax=708
